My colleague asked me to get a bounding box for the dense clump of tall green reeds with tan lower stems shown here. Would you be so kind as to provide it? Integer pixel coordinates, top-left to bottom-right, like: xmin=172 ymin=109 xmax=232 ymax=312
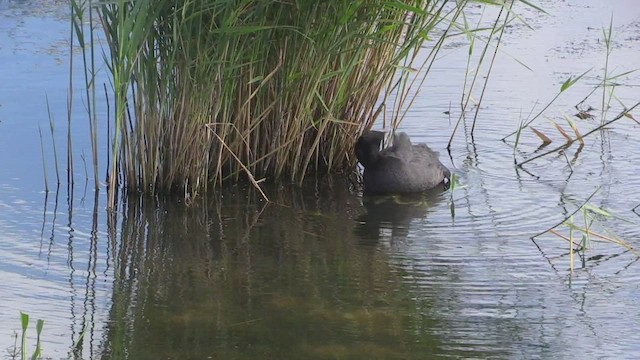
xmin=68 ymin=0 xmax=512 ymax=208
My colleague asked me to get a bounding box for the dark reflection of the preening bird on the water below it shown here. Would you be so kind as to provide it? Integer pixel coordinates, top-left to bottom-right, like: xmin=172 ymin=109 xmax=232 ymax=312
xmin=356 ymin=190 xmax=445 ymax=245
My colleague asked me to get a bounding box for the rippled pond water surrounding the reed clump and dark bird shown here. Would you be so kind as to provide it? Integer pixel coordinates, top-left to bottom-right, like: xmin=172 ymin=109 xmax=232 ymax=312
xmin=0 ymin=0 xmax=640 ymax=359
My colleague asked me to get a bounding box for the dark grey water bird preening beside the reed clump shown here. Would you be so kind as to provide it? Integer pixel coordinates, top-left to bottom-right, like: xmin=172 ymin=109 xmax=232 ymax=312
xmin=356 ymin=131 xmax=451 ymax=194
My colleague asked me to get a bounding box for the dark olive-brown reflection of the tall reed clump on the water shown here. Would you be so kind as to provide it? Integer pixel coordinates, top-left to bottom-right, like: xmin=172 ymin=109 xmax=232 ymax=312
xmin=102 ymin=182 xmax=448 ymax=359
